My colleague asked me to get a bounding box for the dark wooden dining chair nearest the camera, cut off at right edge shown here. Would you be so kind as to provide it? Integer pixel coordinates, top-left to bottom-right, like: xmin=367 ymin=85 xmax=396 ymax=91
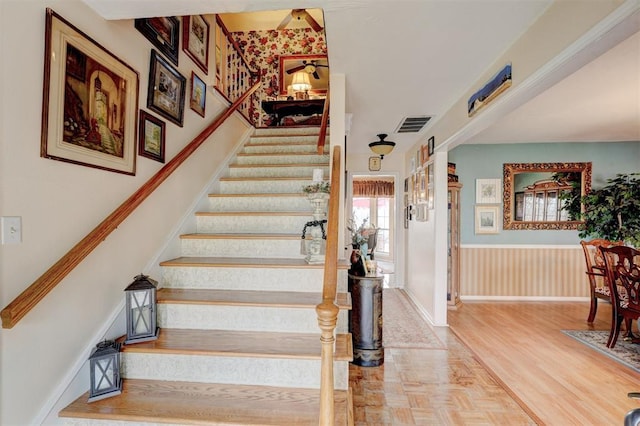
xmin=600 ymin=246 xmax=640 ymax=348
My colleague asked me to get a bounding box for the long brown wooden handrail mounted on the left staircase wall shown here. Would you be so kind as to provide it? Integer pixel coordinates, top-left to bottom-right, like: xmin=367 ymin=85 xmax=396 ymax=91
xmin=0 ymin=82 xmax=261 ymax=328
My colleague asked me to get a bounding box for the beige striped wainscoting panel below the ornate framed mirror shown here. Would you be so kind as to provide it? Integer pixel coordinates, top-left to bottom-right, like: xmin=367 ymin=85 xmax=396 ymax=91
xmin=460 ymin=245 xmax=589 ymax=300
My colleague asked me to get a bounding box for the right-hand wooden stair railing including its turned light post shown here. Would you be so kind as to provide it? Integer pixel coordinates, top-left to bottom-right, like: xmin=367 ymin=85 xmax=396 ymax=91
xmin=316 ymin=146 xmax=341 ymax=426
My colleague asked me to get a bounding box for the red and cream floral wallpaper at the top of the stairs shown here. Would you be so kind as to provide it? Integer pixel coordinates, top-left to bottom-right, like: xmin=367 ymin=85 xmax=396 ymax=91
xmin=231 ymin=28 xmax=327 ymax=126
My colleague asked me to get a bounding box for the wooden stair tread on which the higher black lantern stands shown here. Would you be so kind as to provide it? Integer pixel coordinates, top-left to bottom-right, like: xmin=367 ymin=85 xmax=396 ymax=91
xmin=121 ymin=328 xmax=353 ymax=361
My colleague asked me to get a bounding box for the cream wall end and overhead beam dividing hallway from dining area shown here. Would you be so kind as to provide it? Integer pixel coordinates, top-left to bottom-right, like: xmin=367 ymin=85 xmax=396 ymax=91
xmin=404 ymin=0 xmax=623 ymax=325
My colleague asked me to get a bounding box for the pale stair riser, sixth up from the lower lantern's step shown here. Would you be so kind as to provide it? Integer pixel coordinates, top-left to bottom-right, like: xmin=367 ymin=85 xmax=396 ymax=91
xmin=209 ymin=196 xmax=312 ymax=216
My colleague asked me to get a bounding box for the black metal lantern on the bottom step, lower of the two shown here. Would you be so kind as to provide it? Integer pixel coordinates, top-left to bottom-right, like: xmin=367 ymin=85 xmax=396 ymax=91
xmin=89 ymin=340 xmax=122 ymax=402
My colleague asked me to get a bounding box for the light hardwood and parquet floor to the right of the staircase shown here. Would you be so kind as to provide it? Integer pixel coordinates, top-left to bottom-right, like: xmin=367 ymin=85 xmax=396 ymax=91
xmin=350 ymin=296 xmax=640 ymax=426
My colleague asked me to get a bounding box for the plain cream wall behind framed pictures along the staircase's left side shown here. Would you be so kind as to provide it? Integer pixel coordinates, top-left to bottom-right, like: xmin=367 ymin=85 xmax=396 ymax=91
xmin=0 ymin=0 xmax=247 ymax=425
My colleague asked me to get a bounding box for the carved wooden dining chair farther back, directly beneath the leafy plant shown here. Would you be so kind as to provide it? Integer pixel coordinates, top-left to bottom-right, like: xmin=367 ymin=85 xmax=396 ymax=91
xmin=580 ymin=238 xmax=630 ymax=322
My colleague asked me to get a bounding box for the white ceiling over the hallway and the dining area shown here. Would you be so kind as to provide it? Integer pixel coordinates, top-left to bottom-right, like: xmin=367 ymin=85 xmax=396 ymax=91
xmin=84 ymin=0 xmax=640 ymax=153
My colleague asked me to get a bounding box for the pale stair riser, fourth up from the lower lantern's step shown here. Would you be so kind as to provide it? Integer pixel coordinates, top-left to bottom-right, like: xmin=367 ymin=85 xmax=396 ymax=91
xmin=182 ymin=238 xmax=304 ymax=259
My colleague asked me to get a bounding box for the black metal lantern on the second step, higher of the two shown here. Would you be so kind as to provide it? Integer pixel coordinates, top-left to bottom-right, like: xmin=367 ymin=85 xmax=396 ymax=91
xmin=124 ymin=274 xmax=159 ymax=344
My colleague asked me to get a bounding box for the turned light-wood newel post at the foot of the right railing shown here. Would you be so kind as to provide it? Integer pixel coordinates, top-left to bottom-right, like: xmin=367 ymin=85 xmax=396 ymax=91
xmin=316 ymin=298 xmax=339 ymax=426
